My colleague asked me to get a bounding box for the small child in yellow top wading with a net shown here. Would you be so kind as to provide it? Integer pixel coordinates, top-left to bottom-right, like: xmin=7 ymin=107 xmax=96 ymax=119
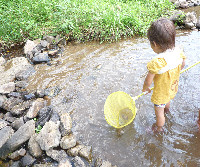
xmin=142 ymin=18 xmax=185 ymax=131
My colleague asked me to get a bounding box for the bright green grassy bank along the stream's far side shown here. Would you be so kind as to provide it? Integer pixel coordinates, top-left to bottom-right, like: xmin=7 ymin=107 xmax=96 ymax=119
xmin=0 ymin=0 xmax=173 ymax=43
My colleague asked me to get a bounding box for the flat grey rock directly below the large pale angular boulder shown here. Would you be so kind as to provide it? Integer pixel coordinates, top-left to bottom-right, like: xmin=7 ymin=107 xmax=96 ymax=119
xmin=46 ymin=149 xmax=68 ymax=162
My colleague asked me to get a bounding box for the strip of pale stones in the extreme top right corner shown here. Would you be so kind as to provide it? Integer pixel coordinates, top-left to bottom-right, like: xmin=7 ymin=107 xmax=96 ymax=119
xmin=170 ymin=0 xmax=200 ymax=9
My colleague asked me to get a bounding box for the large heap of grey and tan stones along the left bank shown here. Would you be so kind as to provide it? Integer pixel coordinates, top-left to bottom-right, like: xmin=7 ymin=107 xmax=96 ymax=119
xmin=0 ymin=39 xmax=117 ymax=167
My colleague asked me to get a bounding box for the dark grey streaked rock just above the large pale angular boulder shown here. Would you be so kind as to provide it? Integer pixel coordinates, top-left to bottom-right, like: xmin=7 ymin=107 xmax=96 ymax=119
xmin=36 ymin=106 xmax=53 ymax=127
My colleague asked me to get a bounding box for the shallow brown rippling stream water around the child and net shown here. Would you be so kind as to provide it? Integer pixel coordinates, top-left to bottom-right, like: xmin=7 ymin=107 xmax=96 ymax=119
xmin=29 ymin=28 xmax=200 ymax=167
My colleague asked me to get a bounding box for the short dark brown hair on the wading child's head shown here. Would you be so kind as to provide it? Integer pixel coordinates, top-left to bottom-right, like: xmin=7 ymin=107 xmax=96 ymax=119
xmin=147 ymin=18 xmax=176 ymax=51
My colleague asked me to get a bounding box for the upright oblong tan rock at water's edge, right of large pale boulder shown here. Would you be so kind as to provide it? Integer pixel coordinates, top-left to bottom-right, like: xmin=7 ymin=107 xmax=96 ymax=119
xmin=60 ymin=113 xmax=72 ymax=136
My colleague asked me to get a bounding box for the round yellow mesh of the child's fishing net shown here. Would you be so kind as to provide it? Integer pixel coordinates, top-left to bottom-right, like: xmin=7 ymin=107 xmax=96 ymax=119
xmin=104 ymin=91 xmax=137 ymax=128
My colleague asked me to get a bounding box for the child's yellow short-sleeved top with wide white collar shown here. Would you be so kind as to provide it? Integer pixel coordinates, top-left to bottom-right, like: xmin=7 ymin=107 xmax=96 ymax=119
xmin=147 ymin=49 xmax=186 ymax=105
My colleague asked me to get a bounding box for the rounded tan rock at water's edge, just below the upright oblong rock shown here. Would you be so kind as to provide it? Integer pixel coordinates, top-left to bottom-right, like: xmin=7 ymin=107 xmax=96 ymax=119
xmin=60 ymin=134 xmax=76 ymax=150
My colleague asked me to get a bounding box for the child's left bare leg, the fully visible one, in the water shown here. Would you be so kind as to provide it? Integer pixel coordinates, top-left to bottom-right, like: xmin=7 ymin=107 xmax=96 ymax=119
xmin=154 ymin=106 xmax=165 ymax=131
